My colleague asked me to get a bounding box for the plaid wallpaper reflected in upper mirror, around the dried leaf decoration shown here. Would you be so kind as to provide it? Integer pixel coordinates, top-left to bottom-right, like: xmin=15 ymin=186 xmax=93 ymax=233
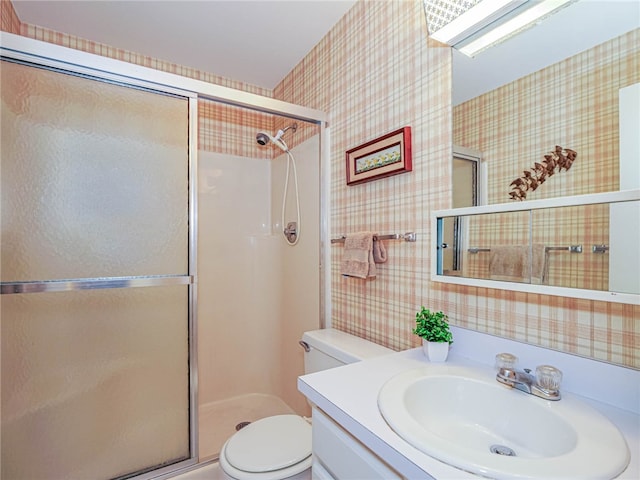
xmin=453 ymin=29 xmax=640 ymax=203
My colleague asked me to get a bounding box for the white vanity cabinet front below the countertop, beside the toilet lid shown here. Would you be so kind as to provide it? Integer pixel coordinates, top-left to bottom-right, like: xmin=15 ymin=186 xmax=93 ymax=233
xmin=311 ymin=407 xmax=402 ymax=480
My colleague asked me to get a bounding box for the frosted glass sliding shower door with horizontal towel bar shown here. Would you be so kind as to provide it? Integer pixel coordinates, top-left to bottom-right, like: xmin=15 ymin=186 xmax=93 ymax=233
xmin=0 ymin=60 xmax=195 ymax=480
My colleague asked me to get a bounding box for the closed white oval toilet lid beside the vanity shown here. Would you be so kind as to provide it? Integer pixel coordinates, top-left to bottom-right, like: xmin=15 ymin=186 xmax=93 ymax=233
xmin=225 ymin=415 xmax=311 ymax=473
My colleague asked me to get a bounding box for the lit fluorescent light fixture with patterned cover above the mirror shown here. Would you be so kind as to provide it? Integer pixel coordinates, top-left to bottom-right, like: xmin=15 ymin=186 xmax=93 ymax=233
xmin=423 ymin=0 xmax=574 ymax=57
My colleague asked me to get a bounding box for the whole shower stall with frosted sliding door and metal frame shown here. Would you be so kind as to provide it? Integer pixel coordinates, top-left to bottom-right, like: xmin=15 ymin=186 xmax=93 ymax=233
xmin=0 ymin=33 xmax=327 ymax=479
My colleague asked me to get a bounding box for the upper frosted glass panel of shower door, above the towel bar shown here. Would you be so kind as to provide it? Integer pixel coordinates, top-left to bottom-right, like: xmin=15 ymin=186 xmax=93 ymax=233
xmin=1 ymin=61 xmax=188 ymax=282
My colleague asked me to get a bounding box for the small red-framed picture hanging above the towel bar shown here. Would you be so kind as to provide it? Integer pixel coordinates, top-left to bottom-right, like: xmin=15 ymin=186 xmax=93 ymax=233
xmin=346 ymin=127 xmax=411 ymax=185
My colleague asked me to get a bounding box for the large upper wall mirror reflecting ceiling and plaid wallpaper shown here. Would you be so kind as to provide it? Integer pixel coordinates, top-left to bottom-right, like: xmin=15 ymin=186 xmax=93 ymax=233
xmin=452 ymin=0 xmax=640 ymax=204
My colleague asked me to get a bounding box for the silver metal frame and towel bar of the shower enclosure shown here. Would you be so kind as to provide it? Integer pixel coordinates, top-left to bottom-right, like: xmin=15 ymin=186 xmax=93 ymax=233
xmin=0 ymin=32 xmax=331 ymax=480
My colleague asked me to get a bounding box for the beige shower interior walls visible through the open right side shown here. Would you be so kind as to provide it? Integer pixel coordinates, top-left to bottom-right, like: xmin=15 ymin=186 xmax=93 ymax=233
xmin=198 ymin=109 xmax=320 ymax=458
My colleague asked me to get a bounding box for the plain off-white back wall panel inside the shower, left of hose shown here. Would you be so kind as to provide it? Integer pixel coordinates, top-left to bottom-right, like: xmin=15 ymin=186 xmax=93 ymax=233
xmin=198 ymin=152 xmax=280 ymax=405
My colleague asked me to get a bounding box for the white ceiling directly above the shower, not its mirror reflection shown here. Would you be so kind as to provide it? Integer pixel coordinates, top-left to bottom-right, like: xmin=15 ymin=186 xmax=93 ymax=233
xmin=12 ymin=0 xmax=356 ymax=89
